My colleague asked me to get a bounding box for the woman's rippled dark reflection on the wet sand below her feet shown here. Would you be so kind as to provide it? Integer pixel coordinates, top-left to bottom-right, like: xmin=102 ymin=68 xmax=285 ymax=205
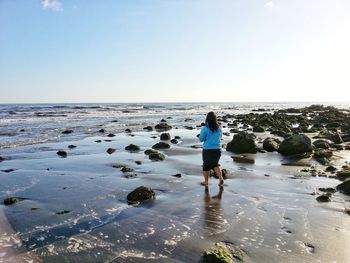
xmin=203 ymin=186 xmax=227 ymax=236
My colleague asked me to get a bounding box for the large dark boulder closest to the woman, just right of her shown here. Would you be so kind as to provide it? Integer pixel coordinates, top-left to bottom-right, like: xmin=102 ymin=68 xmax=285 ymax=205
xmin=226 ymin=131 xmax=258 ymax=153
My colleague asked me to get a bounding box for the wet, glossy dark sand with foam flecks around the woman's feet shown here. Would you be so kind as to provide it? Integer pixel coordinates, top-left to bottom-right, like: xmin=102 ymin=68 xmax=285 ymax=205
xmin=0 ymin=104 xmax=350 ymax=263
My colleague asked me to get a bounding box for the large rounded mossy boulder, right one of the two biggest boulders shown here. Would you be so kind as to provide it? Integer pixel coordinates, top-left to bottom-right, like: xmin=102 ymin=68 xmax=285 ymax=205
xmin=278 ymin=134 xmax=312 ymax=156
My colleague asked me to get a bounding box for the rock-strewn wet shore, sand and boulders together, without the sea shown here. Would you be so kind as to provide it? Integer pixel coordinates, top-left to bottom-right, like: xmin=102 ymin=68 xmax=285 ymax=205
xmin=0 ymin=105 xmax=350 ymax=262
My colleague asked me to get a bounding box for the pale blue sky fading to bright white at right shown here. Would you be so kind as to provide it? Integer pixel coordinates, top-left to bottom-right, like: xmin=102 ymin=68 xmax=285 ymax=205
xmin=0 ymin=0 xmax=350 ymax=103
